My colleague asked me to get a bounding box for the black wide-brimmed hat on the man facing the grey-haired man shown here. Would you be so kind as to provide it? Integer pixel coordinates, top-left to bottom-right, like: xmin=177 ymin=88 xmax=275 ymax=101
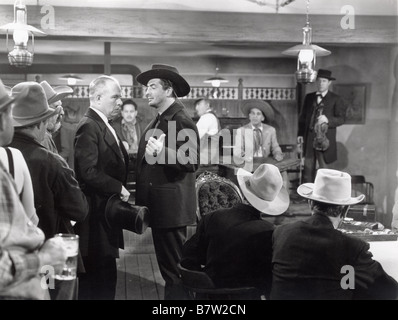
xmin=137 ymin=64 xmax=191 ymax=97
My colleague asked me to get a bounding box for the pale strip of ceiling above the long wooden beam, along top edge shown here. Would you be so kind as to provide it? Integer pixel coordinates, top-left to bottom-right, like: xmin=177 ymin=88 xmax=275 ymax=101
xmin=1 ymin=0 xmax=398 ymax=15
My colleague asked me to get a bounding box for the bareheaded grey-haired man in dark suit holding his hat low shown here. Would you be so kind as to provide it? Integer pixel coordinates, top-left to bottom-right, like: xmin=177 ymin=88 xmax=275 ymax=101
xmin=75 ymin=76 xmax=130 ymax=300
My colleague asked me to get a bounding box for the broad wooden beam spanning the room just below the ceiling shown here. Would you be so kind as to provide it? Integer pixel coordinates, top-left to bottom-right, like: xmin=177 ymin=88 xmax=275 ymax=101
xmin=0 ymin=5 xmax=398 ymax=44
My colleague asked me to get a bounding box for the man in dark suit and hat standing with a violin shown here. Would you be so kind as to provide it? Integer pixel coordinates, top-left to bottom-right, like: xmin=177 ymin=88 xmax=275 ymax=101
xmin=298 ymin=69 xmax=347 ymax=182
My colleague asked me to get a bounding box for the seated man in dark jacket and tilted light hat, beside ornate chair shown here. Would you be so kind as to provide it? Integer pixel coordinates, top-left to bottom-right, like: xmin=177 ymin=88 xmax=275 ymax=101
xmin=181 ymin=164 xmax=289 ymax=297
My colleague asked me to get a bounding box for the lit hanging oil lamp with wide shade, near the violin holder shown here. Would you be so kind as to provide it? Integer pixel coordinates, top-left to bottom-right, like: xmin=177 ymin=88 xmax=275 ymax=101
xmin=282 ymin=0 xmax=331 ymax=83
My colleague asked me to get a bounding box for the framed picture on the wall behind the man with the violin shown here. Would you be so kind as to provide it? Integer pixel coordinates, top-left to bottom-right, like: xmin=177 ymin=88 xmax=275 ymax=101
xmin=333 ymin=83 xmax=366 ymax=124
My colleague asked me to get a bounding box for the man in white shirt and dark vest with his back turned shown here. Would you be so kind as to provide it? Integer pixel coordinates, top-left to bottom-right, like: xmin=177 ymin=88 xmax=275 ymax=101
xmin=195 ymin=98 xmax=221 ymax=165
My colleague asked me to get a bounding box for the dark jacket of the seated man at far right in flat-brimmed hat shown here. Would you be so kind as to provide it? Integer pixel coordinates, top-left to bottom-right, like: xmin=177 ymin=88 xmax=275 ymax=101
xmin=271 ymin=214 xmax=398 ymax=300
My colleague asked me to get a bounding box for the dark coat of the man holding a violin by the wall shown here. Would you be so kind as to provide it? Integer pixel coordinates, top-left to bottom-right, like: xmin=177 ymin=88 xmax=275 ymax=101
xmin=298 ymin=91 xmax=347 ymax=163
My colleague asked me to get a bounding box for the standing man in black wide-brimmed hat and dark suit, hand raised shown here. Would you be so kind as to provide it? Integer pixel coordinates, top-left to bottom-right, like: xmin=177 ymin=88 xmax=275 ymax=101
xmin=136 ymin=64 xmax=199 ymax=299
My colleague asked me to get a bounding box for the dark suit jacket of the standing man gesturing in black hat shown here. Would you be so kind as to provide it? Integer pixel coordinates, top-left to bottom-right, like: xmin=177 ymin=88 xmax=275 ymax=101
xmin=136 ymin=101 xmax=199 ymax=228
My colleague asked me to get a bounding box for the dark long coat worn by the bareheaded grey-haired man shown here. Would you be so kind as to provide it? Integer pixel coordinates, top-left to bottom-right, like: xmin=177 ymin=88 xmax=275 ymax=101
xmin=75 ymin=109 xmax=128 ymax=257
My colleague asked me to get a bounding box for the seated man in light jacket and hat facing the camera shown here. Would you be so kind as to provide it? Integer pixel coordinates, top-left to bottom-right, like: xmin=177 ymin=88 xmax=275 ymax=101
xmin=234 ymin=99 xmax=283 ymax=162
